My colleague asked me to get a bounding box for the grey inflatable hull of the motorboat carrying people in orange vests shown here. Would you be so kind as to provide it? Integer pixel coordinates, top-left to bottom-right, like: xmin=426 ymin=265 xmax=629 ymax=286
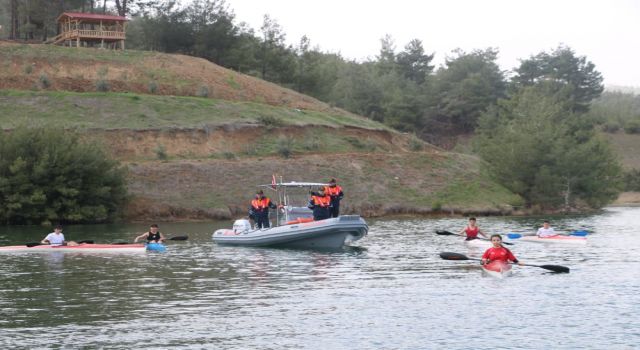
xmin=211 ymin=215 xmax=369 ymax=249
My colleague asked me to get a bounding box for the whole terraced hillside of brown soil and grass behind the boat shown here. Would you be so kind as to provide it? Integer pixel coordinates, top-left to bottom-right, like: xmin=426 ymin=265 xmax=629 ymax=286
xmin=0 ymin=43 xmax=520 ymax=220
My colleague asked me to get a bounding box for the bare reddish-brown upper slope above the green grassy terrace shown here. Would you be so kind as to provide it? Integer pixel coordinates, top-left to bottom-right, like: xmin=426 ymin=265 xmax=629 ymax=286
xmin=0 ymin=41 xmax=348 ymax=114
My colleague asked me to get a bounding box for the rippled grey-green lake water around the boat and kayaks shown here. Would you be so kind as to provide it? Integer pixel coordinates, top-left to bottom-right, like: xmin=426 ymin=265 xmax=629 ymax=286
xmin=0 ymin=208 xmax=640 ymax=349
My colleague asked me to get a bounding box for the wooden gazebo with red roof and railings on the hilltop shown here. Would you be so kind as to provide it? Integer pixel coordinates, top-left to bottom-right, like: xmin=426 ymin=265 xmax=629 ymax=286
xmin=49 ymin=12 xmax=127 ymax=50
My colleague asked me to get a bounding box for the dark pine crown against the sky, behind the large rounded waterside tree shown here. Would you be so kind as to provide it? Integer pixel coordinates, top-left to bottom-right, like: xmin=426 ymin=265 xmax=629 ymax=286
xmin=513 ymin=46 xmax=604 ymax=113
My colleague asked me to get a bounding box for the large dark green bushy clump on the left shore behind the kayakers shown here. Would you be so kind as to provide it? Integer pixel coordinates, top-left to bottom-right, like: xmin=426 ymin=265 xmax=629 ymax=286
xmin=0 ymin=127 xmax=127 ymax=224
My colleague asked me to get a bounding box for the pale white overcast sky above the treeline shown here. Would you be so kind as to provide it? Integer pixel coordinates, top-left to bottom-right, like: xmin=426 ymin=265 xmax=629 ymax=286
xmin=221 ymin=0 xmax=640 ymax=87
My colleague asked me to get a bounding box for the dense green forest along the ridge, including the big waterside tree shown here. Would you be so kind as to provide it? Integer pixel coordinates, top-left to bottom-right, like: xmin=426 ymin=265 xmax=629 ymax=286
xmin=0 ymin=0 xmax=637 ymax=208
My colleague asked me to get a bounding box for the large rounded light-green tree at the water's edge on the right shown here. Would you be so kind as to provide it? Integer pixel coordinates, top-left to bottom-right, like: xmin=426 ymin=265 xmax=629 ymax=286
xmin=476 ymin=86 xmax=621 ymax=208
